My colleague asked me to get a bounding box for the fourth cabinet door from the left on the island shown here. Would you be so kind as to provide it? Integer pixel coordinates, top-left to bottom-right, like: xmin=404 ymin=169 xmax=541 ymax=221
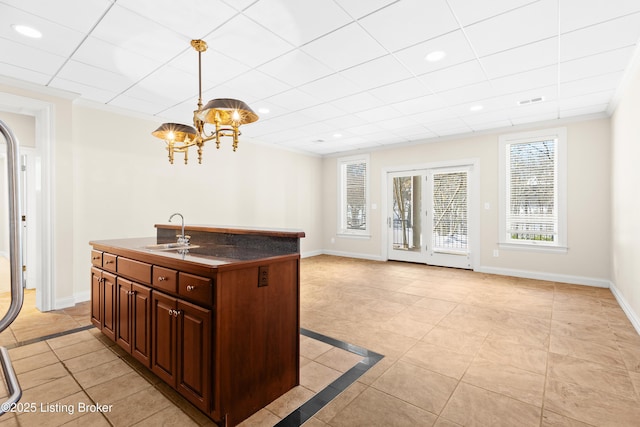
xmin=131 ymin=283 xmax=152 ymax=367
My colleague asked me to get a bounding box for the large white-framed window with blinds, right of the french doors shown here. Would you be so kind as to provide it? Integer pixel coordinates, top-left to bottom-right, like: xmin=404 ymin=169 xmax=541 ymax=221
xmin=499 ymin=128 xmax=567 ymax=250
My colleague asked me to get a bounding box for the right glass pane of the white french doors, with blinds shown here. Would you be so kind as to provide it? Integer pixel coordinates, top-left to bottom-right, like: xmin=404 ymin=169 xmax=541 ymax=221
xmin=433 ymin=172 xmax=468 ymax=252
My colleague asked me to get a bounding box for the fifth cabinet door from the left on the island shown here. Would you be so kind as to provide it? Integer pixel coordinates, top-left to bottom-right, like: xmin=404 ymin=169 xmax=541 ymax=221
xmin=151 ymin=291 xmax=178 ymax=388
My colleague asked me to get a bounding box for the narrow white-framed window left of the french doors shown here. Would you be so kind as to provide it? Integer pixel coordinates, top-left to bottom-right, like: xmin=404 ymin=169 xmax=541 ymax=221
xmin=338 ymin=156 xmax=369 ymax=236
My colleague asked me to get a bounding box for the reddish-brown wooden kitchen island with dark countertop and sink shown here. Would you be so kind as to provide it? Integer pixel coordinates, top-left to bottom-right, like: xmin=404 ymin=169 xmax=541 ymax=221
xmin=90 ymin=224 xmax=304 ymax=426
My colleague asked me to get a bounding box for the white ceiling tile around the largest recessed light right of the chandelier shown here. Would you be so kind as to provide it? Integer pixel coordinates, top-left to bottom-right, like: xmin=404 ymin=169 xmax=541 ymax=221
xmin=394 ymin=30 xmax=476 ymax=75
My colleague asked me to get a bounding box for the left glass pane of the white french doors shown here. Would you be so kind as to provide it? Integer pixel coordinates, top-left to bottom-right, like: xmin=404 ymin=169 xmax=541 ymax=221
xmin=393 ymin=175 xmax=422 ymax=252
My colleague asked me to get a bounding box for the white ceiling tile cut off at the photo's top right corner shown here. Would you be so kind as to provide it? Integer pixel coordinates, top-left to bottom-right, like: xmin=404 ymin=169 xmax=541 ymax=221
xmin=558 ymin=0 xmax=640 ymax=34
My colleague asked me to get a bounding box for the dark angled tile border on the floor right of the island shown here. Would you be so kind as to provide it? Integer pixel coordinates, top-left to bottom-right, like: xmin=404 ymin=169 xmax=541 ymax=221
xmin=276 ymin=328 xmax=384 ymax=427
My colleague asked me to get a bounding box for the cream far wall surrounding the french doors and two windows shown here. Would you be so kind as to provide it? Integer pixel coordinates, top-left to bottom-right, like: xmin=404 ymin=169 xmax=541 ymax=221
xmin=323 ymin=118 xmax=611 ymax=286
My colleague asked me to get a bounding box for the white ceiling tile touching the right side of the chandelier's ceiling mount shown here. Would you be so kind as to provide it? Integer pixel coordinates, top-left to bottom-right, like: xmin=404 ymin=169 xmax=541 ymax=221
xmin=204 ymin=15 xmax=293 ymax=68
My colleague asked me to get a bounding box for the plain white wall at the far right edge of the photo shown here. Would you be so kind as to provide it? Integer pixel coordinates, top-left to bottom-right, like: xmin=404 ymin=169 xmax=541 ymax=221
xmin=611 ymin=56 xmax=640 ymax=332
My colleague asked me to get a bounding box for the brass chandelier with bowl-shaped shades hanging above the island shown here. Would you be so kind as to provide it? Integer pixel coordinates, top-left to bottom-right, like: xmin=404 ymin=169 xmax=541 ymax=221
xmin=151 ymin=40 xmax=258 ymax=165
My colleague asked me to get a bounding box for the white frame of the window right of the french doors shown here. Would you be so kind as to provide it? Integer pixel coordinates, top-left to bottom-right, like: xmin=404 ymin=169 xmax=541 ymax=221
xmin=498 ymin=127 xmax=568 ymax=252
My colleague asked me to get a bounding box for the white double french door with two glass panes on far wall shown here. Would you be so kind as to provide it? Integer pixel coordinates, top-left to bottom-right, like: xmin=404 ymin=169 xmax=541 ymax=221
xmin=387 ymin=166 xmax=471 ymax=268
